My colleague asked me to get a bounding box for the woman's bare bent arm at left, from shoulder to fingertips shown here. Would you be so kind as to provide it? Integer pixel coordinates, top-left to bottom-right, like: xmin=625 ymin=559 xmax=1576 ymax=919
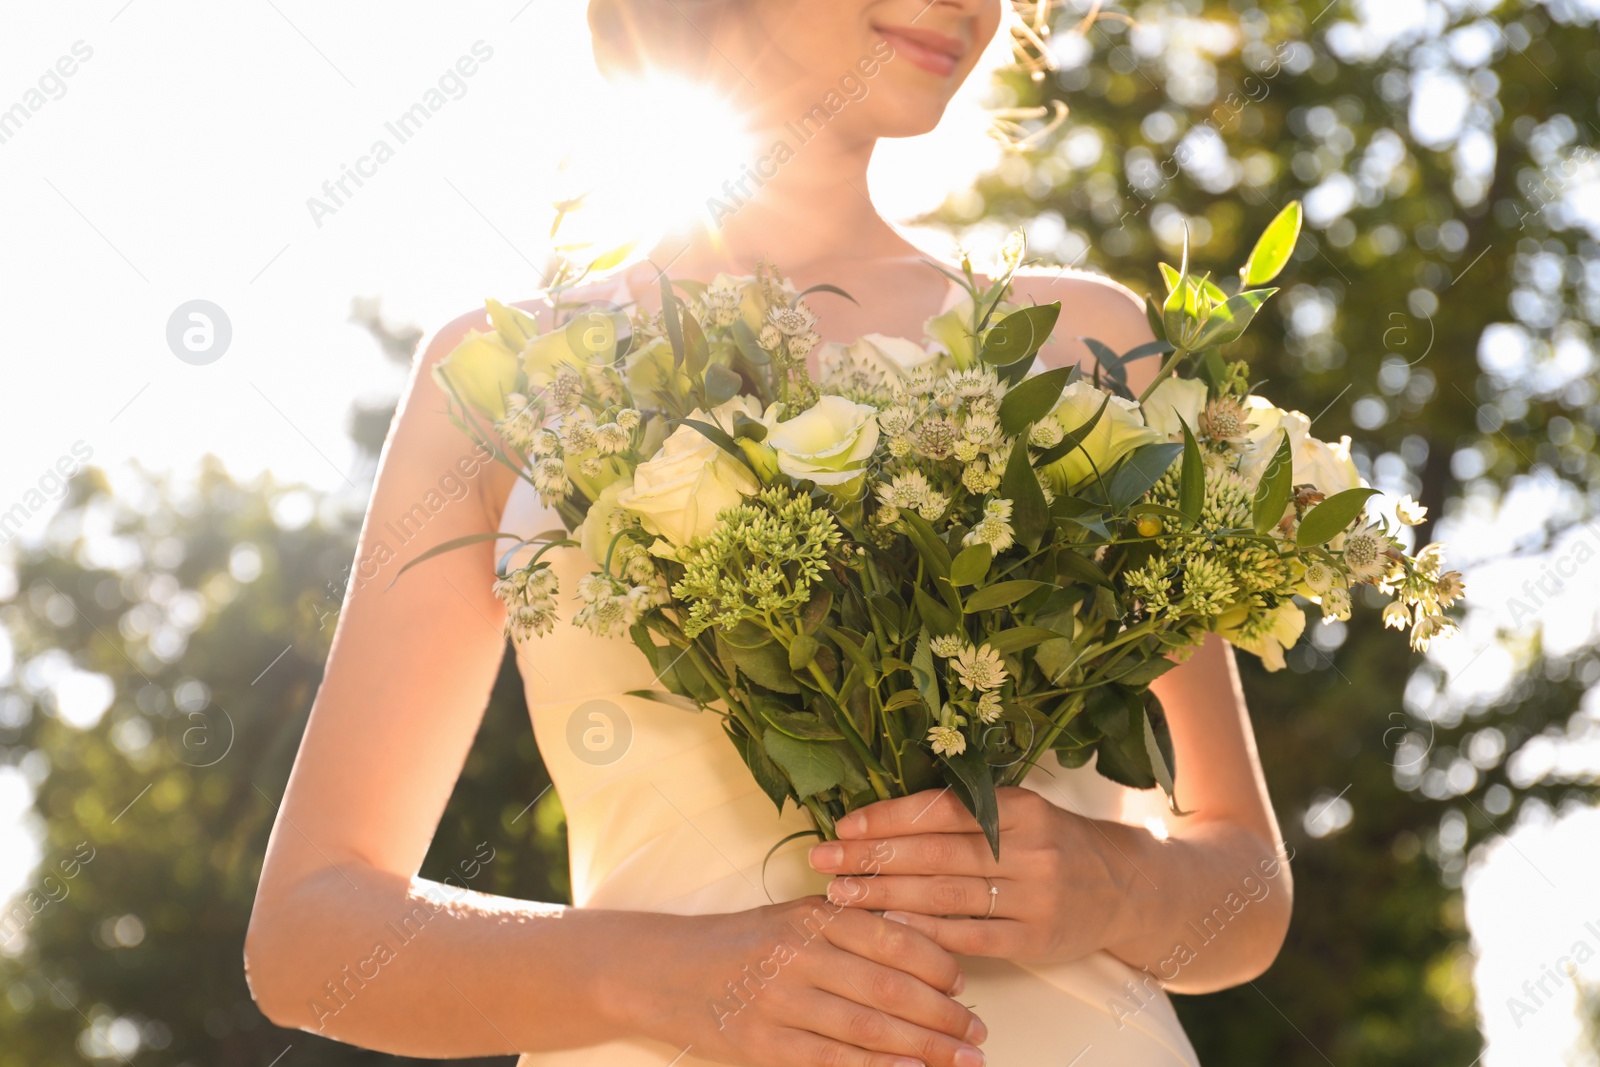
xmin=245 ymin=303 xmax=982 ymax=1067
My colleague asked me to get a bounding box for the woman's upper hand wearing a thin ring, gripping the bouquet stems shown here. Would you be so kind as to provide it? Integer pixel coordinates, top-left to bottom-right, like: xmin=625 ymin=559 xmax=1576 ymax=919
xmin=811 ymin=787 xmax=1138 ymax=961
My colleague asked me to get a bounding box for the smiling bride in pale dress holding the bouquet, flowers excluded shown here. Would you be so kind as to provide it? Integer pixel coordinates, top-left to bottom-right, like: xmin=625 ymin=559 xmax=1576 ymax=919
xmin=245 ymin=0 xmax=1291 ymax=1067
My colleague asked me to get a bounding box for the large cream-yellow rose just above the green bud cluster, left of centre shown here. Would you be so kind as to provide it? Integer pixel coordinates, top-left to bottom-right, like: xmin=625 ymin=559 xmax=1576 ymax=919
xmin=616 ymin=397 xmax=762 ymax=547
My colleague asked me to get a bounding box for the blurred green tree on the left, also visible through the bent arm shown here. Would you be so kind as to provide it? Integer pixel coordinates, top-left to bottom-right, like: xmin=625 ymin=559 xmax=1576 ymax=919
xmin=0 ymin=309 xmax=568 ymax=1067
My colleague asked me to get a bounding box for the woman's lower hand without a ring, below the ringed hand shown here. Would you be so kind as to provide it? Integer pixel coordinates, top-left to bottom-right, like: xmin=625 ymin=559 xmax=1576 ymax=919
xmin=627 ymin=896 xmax=987 ymax=1067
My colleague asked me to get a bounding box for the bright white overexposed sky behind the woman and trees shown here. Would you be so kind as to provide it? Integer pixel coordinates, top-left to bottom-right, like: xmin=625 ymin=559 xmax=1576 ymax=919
xmin=0 ymin=0 xmax=1600 ymax=1065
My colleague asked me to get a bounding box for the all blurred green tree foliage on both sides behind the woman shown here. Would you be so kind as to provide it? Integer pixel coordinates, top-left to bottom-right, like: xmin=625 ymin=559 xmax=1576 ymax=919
xmin=0 ymin=0 xmax=1600 ymax=1067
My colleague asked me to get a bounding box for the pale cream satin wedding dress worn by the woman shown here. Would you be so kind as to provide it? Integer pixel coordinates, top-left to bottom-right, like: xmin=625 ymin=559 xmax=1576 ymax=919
xmin=499 ymin=502 xmax=1198 ymax=1067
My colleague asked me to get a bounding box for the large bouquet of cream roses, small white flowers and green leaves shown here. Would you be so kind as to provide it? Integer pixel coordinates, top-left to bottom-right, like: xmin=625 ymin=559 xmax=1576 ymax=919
xmin=413 ymin=205 xmax=1462 ymax=856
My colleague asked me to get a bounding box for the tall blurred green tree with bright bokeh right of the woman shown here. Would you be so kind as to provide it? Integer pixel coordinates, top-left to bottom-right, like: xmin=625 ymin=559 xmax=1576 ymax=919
xmin=938 ymin=0 xmax=1600 ymax=1065
